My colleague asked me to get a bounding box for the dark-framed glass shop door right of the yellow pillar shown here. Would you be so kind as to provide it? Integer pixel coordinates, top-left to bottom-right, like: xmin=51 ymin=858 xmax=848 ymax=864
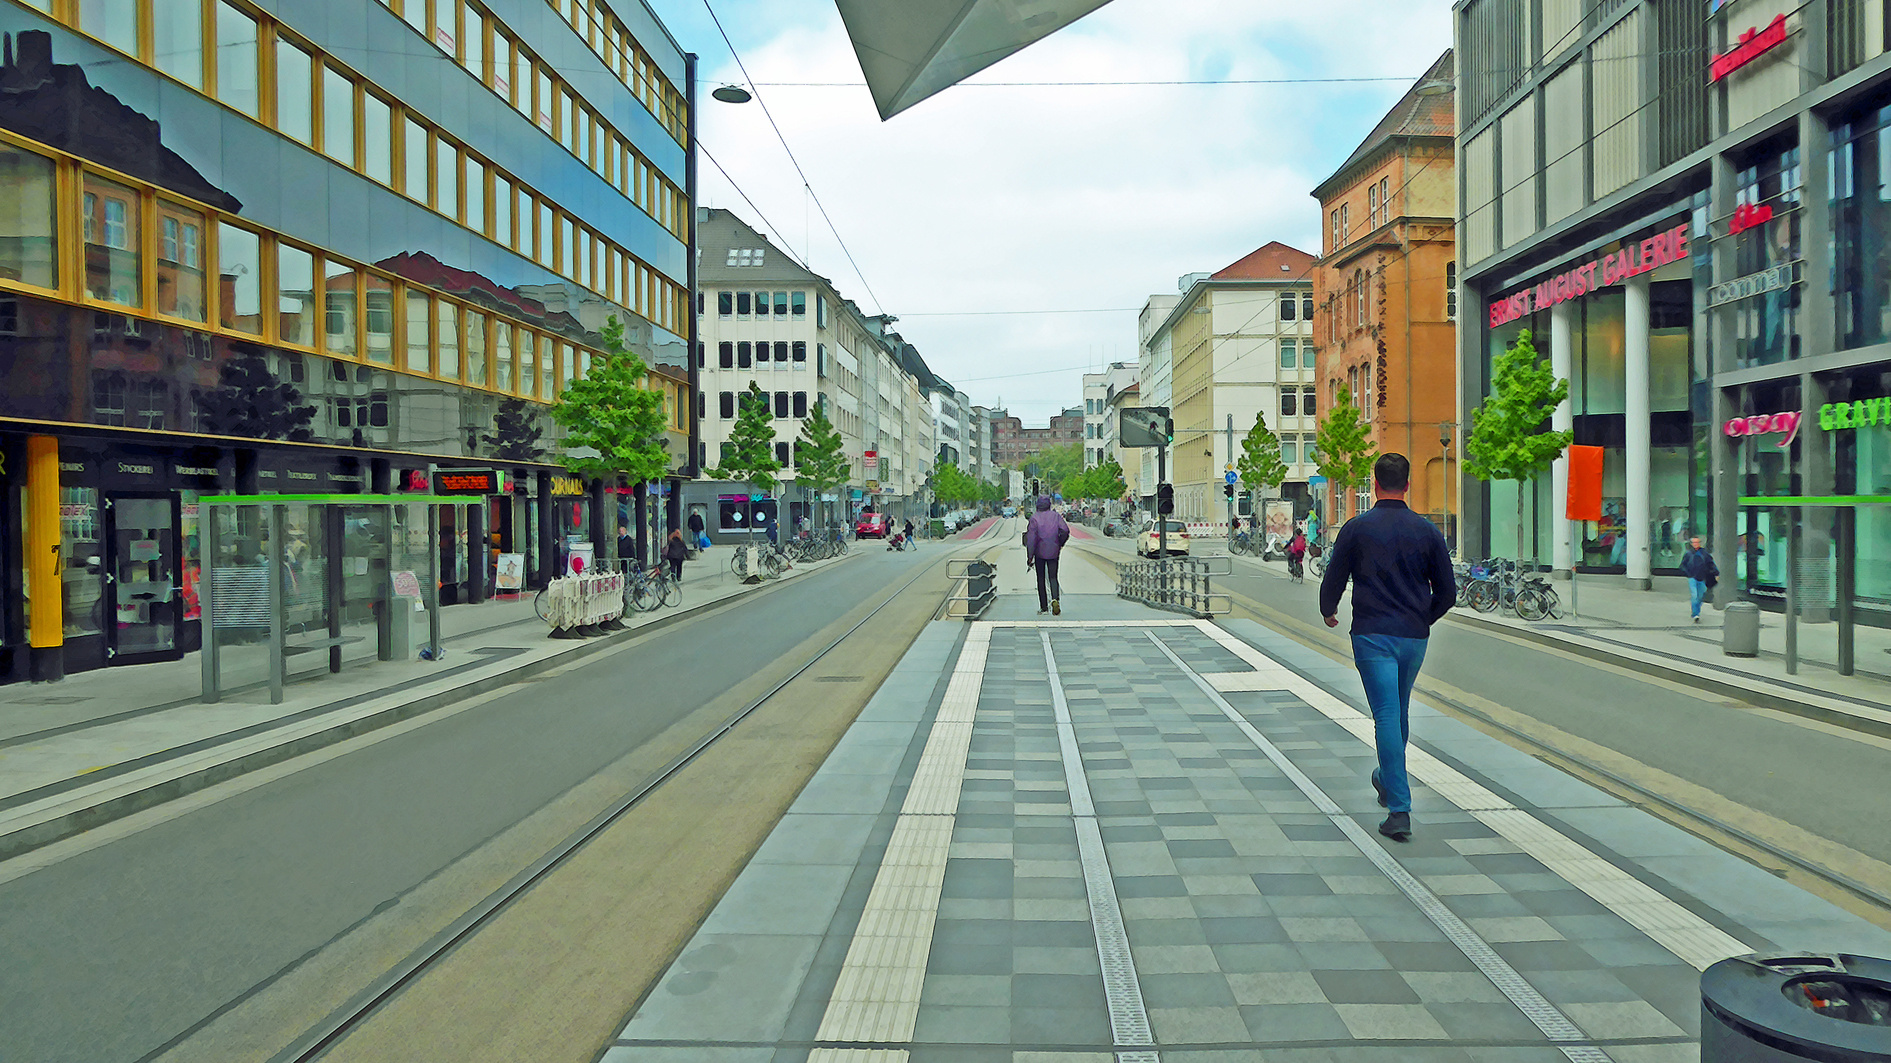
xmin=104 ymin=494 xmax=183 ymax=664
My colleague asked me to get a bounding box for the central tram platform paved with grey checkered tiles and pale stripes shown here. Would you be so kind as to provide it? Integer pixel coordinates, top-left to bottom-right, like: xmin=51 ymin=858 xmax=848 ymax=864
xmin=603 ymin=582 xmax=1891 ymax=1063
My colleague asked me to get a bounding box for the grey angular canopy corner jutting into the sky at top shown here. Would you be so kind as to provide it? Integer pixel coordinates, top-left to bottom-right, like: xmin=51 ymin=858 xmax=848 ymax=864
xmin=836 ymin=0 xmax=1110 ymax=121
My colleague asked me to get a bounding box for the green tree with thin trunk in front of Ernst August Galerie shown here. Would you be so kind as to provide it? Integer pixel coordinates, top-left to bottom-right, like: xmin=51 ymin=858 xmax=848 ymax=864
xmin=1464 ymin=329 xmax=1575 ymax=562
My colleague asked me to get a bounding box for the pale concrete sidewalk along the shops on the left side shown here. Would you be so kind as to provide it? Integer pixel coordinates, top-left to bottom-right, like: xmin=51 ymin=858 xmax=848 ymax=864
xmin=0 ymin=550 xmax=845 ymax=859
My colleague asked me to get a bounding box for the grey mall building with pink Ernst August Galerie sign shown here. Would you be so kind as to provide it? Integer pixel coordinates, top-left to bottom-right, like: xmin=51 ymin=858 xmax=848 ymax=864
xmin=1456 ymin=0 xmax=1891 ymax=646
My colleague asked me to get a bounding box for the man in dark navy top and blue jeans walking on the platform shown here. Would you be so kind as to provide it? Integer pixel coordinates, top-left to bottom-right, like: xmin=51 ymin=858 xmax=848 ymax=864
xmin=1320 ymin=454 xmax=1458 ymax=842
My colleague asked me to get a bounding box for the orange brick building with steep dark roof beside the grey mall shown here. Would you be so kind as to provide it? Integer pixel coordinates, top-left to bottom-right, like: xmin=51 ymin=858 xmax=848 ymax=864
xmin=1316 ymin=51 xmax=1458 ymax=532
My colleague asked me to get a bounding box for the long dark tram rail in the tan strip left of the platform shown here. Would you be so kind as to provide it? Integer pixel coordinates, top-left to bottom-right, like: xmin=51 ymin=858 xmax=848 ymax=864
xmin=270 ymin=520 xmax=1004 ymax=1063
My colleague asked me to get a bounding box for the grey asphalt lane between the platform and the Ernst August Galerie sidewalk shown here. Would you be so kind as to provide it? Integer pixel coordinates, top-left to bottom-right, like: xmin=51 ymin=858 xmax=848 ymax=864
xmin=1085 ymin=539 xmax=1891 ymax=877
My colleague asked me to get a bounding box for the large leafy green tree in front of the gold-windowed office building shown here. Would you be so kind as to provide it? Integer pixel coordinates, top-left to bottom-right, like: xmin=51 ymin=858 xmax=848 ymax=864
xmin=552 ymin=318 xmax=669 ymax=484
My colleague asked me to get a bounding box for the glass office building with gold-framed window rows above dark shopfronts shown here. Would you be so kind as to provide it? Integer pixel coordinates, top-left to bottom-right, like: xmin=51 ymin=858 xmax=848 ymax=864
xmin=0 ymin=0 xmax=694 ymax=679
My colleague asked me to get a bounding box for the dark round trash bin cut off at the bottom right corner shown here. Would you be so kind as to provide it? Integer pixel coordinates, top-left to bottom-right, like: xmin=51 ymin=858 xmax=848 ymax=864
xmin=1700 ymin=953 xmax=1891 ymax=1063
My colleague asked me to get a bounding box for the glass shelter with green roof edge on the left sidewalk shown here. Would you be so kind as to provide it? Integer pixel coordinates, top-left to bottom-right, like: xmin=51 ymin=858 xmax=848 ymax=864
xmin=201 ymin=494 xmax=448 ymax=704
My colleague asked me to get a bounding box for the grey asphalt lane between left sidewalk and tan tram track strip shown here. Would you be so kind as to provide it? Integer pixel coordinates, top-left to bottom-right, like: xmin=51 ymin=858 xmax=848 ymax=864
xmin=0 ymin=543 xmax=975 ymax=1063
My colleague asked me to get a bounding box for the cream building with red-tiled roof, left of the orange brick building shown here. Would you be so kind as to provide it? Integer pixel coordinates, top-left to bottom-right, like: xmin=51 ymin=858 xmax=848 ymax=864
xmin=1144 ymin=240 xmax=1316 ymax=522
